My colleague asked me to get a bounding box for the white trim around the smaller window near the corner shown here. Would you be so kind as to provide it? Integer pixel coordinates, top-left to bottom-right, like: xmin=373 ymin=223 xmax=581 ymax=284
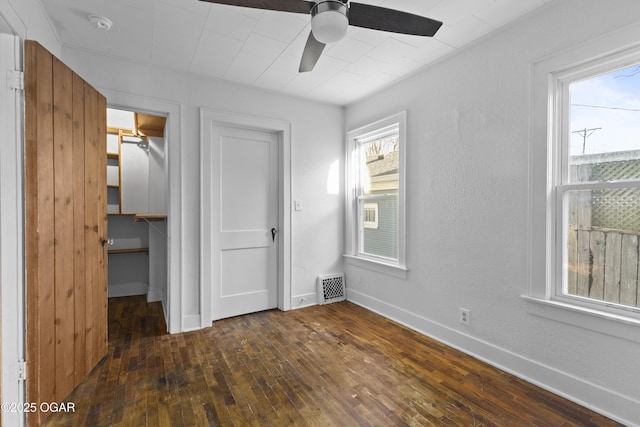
xmin=344 ymin=111 xmax=407 ymax=278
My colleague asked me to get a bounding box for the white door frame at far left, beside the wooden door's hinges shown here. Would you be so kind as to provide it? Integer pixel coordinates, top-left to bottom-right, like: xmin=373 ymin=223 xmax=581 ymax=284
xmin=0 ymin=28 xmax=25 ymax=426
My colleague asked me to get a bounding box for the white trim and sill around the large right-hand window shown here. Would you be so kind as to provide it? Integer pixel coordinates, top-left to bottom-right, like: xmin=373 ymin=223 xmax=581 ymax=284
xmin=523 ymin=24 xmax=640 ymax=341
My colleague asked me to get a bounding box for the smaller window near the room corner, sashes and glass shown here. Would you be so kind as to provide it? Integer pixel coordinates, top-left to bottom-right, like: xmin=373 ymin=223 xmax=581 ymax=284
xmin=347 ymin=109 xmax=405 ymax=268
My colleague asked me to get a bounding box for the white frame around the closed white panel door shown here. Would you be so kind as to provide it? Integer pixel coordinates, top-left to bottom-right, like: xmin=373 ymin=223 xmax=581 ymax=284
xmin=200 ymin=108 xmax=291 ymax=328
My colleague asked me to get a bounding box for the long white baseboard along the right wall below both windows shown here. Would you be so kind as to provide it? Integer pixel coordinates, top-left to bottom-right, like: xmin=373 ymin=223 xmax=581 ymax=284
xmin=348 ymin=289 xmax=640 ymax=427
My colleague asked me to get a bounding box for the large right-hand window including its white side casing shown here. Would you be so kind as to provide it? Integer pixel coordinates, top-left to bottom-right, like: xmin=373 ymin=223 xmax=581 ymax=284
xmin=530 ymin=41 xmax=640 ymax=330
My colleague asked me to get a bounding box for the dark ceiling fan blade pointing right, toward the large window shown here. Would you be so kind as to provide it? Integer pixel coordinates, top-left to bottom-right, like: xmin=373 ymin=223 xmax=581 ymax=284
xmin=349 ymin=3 xmax=442 ymax=37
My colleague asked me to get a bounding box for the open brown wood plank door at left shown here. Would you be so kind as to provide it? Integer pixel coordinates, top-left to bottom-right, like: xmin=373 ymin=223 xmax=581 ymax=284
xmin=24 ymin=41 xmax=107 ymax=425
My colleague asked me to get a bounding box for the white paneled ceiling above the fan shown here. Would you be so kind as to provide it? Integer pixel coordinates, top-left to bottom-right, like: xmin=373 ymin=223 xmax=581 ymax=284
xmin=42 ymin=0 xmax=552 ymax=105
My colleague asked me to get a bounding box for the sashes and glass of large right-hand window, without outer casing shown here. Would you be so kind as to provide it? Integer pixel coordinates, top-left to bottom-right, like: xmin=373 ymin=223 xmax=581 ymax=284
xmin=555 ymin=57 xmax=640 ymax=311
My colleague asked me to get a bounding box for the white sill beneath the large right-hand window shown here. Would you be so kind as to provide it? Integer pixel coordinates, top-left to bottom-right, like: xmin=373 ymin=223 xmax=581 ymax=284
xmin=522 ymin=295 xmax=640 ymax=343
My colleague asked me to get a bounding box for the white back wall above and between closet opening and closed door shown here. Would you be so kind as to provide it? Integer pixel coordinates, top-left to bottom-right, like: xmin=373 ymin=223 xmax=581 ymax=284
xmin=62 ymin=48 xmax=344 ymax=328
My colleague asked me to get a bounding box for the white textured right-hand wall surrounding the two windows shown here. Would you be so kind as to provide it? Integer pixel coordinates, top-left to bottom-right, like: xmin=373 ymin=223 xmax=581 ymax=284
xmin=346 ymin=0 xmax=640 ymax=424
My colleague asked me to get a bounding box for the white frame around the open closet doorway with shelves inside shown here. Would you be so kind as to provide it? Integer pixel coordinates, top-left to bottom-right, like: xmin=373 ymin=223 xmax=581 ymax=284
xmin=98 ymin=88 xmax=181 ymax=334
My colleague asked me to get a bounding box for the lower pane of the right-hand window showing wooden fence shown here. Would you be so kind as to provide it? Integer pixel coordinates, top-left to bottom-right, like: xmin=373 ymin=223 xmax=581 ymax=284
xmin=563 ymin=188 xmax=640 ymax=307
